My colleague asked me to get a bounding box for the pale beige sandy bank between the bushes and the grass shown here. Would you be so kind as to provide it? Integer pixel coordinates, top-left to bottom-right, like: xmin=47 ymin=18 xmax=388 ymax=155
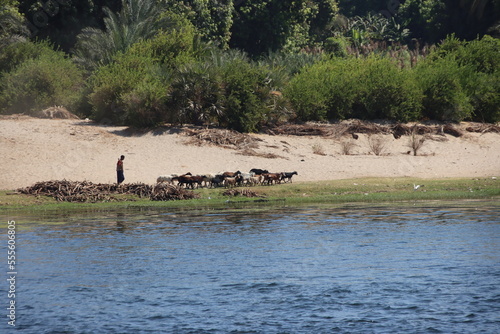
xmin=0 ymin=116 xmax=500 ymax=190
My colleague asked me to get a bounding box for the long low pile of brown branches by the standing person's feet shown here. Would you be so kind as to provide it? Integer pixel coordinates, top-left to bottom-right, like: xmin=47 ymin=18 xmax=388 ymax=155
xmin=18 ymin=180 xmax=197 ymax=203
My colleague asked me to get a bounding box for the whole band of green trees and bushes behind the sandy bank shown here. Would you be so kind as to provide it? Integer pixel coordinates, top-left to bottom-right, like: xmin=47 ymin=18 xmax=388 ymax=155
xmin=0 ymin=0 xmax=500 ymax=128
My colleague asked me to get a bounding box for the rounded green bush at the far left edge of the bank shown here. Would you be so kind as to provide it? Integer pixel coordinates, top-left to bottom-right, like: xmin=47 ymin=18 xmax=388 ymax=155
xmin=0 ymin=44 xmax=83 ymax=113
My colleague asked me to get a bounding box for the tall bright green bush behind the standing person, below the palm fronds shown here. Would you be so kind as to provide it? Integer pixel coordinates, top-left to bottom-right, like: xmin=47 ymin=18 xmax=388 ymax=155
xmin=89 ymin=15 xmax=202 ymax=127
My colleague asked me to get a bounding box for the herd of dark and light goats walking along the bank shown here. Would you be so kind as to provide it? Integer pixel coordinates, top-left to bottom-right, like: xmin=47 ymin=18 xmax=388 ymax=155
xmin=156 ymin=168 xmax=298 ymax=189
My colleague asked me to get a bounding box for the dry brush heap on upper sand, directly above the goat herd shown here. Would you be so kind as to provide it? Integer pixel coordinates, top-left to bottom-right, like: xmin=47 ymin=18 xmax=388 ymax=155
xmin=184 ymin=129 xmax=260 ymax=149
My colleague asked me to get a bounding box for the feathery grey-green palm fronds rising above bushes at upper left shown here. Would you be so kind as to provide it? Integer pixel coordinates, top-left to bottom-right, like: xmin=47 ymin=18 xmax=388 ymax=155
xmin=74 ymin=0 xmax=172 ymax=70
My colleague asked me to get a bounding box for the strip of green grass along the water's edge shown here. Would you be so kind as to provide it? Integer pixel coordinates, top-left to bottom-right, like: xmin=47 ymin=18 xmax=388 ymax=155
xmin=0 ymin=177 xmax=500 ymax=213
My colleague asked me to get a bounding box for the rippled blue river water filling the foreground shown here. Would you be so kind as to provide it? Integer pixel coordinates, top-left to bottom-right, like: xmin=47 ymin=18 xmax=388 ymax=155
xmin=0 ymin=202 xmax=500 ymax=334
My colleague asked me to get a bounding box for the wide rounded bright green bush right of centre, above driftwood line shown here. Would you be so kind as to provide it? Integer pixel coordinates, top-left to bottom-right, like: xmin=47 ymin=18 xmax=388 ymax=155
xmin=286 ymin=57 xmax=421 ymax=121
